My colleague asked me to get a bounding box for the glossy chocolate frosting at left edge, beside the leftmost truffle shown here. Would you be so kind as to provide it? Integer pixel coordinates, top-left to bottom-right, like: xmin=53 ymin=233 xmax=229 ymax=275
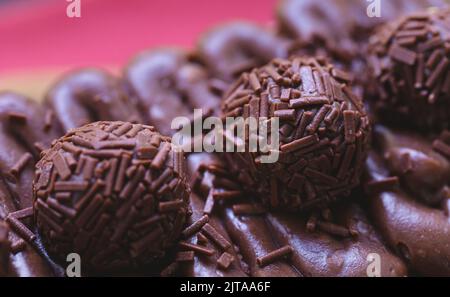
xmin=0 ymin=92 xmax=60 ymax=276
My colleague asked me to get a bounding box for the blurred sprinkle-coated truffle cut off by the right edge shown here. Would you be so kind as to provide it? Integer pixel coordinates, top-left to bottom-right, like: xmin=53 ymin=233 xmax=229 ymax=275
xmin=368 ymin=9 xmax=450 ymax=130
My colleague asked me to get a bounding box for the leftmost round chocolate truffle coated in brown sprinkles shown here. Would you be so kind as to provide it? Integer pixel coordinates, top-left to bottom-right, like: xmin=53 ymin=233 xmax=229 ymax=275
xmin=33 ymin=122 xmax=190 ymax=271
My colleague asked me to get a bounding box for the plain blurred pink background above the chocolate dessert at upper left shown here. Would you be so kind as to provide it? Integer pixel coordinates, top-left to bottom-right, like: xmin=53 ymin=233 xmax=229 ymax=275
xmin=0 ymin=0 xmax=277 ymax=74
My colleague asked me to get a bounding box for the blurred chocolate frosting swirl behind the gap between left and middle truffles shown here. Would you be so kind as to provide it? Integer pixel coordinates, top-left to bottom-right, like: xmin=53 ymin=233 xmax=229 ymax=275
xmin=124 ymin=48 xmax=219 ymax=135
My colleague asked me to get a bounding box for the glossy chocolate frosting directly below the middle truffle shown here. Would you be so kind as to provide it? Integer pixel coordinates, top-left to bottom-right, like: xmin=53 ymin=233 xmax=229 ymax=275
xmin=188 ymin=154 xmax=407 ymax=276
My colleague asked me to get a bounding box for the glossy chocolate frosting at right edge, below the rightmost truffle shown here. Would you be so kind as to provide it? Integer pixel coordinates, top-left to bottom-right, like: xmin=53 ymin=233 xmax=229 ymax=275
xmin=367 ymin=126 xmax=450 ymax=276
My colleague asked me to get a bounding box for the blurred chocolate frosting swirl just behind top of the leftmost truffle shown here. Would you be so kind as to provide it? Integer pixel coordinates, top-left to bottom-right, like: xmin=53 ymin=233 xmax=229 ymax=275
xmin=45 ymin=69 xmax=143 ymax=131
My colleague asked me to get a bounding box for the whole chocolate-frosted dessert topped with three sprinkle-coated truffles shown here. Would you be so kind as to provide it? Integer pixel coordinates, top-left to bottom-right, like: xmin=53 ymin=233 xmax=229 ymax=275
xmin=0 ymin=0 xmax=450 ymax=277
